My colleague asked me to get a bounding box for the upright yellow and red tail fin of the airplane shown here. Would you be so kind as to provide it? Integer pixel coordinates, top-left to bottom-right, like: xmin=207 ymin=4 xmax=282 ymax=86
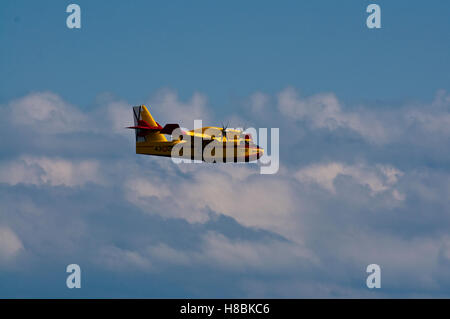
xmin=130 ymin=105 xmax=167 ymax=142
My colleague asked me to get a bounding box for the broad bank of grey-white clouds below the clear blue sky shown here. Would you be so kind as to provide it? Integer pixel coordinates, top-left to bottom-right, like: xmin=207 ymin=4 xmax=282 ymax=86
xmin=0 ymin=88 xmax=450 ymax=297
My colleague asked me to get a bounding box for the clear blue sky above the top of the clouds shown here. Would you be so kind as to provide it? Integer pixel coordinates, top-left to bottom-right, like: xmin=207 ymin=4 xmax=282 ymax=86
xmin=0 ymin=1 xmax=450 ymax=108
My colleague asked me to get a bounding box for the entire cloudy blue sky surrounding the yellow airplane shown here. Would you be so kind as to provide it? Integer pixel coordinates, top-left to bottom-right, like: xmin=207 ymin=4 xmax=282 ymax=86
xmin=0 ymin=0 xmax=450 ymax=298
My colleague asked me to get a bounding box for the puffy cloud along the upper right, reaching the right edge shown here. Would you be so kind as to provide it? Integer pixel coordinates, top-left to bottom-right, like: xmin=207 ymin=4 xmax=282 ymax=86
xmin=278 ymin=88 xmax=450 ymax=145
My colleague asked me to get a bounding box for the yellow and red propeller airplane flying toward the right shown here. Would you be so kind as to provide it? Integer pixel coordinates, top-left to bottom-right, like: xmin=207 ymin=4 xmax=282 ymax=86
xmin=128 ymin=105 xmax=264 ymax=163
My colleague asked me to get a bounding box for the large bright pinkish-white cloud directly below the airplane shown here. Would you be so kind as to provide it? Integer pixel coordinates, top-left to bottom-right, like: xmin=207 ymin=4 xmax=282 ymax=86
xmin=124 ymin=164 xmax=301 ymax=237
